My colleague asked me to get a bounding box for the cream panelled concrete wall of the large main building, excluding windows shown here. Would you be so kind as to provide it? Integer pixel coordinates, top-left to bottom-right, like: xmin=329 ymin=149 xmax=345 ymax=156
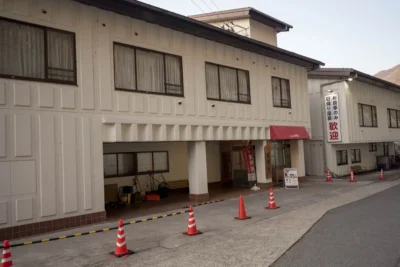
xmin=0 ymin=0 xmax=310 ymax=228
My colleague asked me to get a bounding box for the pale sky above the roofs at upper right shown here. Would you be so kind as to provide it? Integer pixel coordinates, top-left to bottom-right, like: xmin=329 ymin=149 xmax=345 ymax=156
xmin=141 ymin=0 xmax=400 ymax=75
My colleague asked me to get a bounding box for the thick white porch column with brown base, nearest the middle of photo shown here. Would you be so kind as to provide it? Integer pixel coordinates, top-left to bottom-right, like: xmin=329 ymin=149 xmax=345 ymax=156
xmin=188 ymin=141 xmax=209 ymax=201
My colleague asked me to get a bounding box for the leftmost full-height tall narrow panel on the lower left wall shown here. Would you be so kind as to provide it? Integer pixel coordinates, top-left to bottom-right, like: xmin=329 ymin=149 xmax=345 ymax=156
xmin=38 ymin=113 xmax=57 ymax=217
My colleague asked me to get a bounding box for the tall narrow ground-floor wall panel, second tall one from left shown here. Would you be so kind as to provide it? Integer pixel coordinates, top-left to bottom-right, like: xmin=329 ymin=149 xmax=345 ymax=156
xmin=61 ymin=114 xmax=78 ymax=213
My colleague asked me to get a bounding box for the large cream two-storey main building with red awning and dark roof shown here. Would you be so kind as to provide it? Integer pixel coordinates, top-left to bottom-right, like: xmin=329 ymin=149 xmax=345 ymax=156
xmin=0 ymin=0 xmax=322 ymax=239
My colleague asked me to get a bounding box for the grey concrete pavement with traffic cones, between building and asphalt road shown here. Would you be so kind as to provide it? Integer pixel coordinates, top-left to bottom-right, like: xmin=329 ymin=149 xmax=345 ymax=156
xmin=7 ymin=171 xmax=400 ymax=266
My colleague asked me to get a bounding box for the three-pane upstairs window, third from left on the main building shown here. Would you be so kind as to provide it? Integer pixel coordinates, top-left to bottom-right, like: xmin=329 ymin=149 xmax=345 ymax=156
xmin=206 ymin=63 xmax=251 ymax=104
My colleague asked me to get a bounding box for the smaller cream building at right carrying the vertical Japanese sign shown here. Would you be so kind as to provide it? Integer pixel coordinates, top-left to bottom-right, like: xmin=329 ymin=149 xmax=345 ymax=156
xmin=305 ymin=68 xmax=400 ymax=175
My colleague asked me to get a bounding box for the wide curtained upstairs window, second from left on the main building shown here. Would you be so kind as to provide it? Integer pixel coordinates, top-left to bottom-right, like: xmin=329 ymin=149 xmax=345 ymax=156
xmin=114 ymin=43 xmax=183 ymax=96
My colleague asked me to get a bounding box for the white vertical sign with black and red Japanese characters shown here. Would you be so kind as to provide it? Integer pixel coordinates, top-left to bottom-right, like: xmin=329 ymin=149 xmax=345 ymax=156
xmin=325 ymin=93 xmax=342 ymax=143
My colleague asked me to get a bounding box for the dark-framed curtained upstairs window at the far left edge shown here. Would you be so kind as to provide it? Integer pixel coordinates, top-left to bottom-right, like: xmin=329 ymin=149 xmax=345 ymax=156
xmin=0 ymin=18 xmax=77 ymax=84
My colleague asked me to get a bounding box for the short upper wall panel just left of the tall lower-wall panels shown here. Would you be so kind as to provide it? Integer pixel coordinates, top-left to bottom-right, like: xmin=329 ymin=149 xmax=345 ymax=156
xmin=13 ymin=112 xmax=32 ymax=157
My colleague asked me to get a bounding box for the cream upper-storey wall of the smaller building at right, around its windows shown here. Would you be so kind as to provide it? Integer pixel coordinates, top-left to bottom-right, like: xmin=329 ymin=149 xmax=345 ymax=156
xmin=308 ymin=79 xmax=400 ymax=143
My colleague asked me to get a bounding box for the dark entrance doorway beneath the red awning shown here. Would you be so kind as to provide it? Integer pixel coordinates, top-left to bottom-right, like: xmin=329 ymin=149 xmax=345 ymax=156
xmin=271 ymin=142 xmax=292 ymax=185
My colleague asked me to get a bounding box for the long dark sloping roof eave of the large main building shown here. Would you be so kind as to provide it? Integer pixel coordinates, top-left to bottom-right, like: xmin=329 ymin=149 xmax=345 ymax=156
xmin=74 ymin=0 xmax=324 ymax=70
